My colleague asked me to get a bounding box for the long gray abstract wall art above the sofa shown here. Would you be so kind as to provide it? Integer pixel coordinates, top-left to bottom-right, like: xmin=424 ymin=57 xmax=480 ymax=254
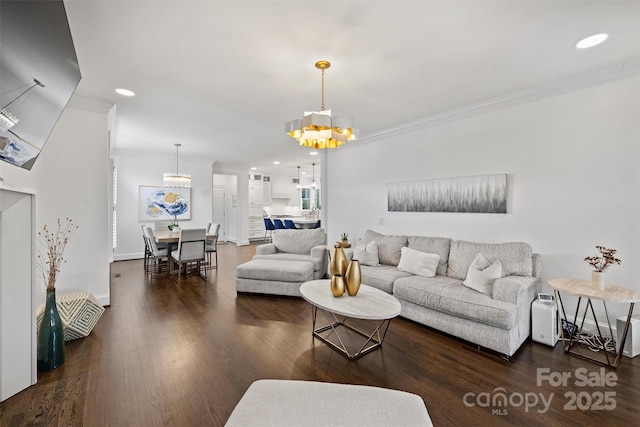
xmin=387 ymin=174 xmax=507 ymax=213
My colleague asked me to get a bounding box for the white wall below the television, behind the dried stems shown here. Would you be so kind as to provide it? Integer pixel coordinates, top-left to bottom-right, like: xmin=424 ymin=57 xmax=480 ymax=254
xmin=0 ymin=108 xmax=111 ymax=305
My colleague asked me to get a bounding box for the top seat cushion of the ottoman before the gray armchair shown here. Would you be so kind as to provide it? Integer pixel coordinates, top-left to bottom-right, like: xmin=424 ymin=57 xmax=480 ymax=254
xmin=236 ymin=259 xmax=313 ymax=283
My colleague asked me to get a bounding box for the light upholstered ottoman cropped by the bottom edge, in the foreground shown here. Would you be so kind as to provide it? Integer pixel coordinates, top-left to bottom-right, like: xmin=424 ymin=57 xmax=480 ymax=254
xmin=225 ymin=380 xmax=433 ymax=427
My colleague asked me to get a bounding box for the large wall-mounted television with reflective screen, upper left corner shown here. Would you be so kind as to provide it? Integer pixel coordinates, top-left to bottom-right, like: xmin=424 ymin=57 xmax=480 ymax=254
xmin=0 ymin=0 xmax=82 ymax=170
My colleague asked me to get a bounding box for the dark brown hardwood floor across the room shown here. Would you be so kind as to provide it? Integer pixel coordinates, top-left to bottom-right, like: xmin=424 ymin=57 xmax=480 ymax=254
xmin=0 ymin=244 xmax=640 ymax=427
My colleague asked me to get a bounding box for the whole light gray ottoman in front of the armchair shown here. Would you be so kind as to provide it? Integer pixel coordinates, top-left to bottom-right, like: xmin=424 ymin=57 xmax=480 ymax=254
xmin=236 ymin=259 xmax=313 ymax=297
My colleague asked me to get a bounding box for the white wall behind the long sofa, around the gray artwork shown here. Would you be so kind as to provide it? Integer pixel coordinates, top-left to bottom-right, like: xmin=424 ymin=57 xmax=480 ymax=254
xmin=324 ymin=77 xmax=640 ymax=317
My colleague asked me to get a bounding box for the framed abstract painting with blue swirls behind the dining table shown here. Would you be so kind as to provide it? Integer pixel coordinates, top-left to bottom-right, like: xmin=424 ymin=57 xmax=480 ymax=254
xmin=138 ymin=185 xmax=191 ymax=221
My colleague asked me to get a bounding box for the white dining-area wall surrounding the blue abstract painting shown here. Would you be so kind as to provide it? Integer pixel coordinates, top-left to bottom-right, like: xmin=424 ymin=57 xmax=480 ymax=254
xmin=112 ymin=150 xmax=213 ymax=261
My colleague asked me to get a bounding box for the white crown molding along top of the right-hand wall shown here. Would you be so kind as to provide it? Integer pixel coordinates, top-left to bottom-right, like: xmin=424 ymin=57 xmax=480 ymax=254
xmin=360 ymin=57 xmax=640 ymax=142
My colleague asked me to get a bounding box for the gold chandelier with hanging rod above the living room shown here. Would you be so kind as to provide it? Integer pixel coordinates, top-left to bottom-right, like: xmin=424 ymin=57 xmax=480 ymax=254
xmin=285 ymin=60 xmax=358 ymax=150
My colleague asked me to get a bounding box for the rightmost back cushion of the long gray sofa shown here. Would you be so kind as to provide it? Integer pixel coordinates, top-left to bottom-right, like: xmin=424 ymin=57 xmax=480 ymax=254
xmin=447 ymin=240 xmax=533 ymax=280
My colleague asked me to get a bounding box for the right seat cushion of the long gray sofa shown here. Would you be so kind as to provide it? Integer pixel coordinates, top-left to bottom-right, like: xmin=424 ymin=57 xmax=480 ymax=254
xmin=393 ymin=276 xmax=528 ymax=329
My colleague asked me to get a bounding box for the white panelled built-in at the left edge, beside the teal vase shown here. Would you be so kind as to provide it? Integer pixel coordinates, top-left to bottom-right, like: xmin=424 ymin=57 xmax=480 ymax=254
xmin=0 ymin=183 xmax=37 ymax=401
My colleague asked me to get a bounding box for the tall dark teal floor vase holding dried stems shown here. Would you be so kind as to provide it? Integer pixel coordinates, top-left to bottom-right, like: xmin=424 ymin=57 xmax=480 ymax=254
xmin=37 ymin=218 xmax=78 ymax=371
